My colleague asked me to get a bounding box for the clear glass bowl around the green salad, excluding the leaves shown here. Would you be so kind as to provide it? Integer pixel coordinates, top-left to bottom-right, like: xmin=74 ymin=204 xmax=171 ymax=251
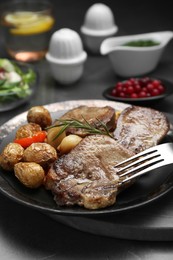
xmin=0 ymin=60 xmax=39 ymax=112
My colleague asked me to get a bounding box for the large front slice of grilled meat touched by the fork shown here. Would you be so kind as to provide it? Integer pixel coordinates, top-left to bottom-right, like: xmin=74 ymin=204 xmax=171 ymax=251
xmin=45 ymin=135 xmax=133 ymax=209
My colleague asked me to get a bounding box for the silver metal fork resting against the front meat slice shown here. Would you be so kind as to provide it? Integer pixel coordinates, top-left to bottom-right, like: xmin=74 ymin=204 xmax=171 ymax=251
xmin=115 ymin=143 xmax=173 ymax=184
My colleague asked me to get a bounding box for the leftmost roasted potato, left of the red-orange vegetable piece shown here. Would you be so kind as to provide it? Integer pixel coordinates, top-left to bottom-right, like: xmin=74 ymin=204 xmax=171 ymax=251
xmin=0 ymin=143 xmax=24 ymax=171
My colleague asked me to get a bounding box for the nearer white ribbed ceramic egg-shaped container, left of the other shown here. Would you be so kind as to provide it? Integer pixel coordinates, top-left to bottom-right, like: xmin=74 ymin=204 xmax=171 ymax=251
xmin=46 ymin=28 xmax=87 ymax=85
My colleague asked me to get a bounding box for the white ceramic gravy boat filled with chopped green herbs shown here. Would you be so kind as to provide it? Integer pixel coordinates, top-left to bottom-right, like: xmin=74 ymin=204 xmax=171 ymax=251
xmin=100 ymin=31 xmax=173 ymax=77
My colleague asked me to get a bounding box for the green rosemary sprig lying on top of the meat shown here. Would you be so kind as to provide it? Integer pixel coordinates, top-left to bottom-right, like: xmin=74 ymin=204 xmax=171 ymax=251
xmin=47 ymin=118 xmax=113 ymax=141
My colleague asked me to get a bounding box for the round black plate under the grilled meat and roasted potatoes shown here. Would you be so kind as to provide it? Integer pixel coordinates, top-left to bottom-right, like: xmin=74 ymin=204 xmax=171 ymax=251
xmin=0 ymin=100 xmax=173 ymax=216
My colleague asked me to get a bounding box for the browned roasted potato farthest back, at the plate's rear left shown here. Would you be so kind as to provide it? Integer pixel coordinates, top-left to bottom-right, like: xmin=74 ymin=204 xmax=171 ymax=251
xmin=27 ymin=106 xmax=52 ymax=129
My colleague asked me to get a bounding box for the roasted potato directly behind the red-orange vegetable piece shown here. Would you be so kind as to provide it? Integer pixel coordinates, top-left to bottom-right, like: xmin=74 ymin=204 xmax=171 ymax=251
xmin=16 ymin=123 xmax=42 ymax=139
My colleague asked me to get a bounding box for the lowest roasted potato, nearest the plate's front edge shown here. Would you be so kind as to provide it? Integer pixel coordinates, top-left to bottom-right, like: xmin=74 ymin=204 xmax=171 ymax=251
xmin=14 ymin=162 xmax=45 ymax=189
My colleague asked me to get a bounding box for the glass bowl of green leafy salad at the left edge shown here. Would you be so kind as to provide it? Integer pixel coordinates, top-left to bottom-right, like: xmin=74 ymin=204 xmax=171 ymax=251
xmin=0 ymin=59 xmax=38 ymax=112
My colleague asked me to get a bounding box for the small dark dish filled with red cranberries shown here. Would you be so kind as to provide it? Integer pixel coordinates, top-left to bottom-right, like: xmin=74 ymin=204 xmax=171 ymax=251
xmin=103 ymin=77 xmax=173 ymax=103
